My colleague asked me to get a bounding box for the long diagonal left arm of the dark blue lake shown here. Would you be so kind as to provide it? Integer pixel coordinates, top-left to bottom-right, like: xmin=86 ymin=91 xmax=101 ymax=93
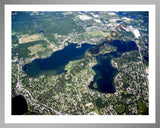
xmin=23 ymin=43 xmax=94 ymax=77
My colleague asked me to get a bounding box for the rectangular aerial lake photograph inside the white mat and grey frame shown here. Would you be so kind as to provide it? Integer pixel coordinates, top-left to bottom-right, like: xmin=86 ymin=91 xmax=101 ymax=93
xmin=11 ymin=11 xmax=149 ymax=115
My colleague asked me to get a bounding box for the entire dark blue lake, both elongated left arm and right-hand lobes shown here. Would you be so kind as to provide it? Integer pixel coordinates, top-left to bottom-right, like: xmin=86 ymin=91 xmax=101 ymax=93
xmin=23 ymin=40 xmax=138 ymax=93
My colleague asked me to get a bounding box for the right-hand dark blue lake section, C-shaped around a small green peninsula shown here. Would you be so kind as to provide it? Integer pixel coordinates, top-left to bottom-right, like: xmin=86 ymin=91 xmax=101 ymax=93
xmin=89 ymin=40 xmax=138 ymax=93
